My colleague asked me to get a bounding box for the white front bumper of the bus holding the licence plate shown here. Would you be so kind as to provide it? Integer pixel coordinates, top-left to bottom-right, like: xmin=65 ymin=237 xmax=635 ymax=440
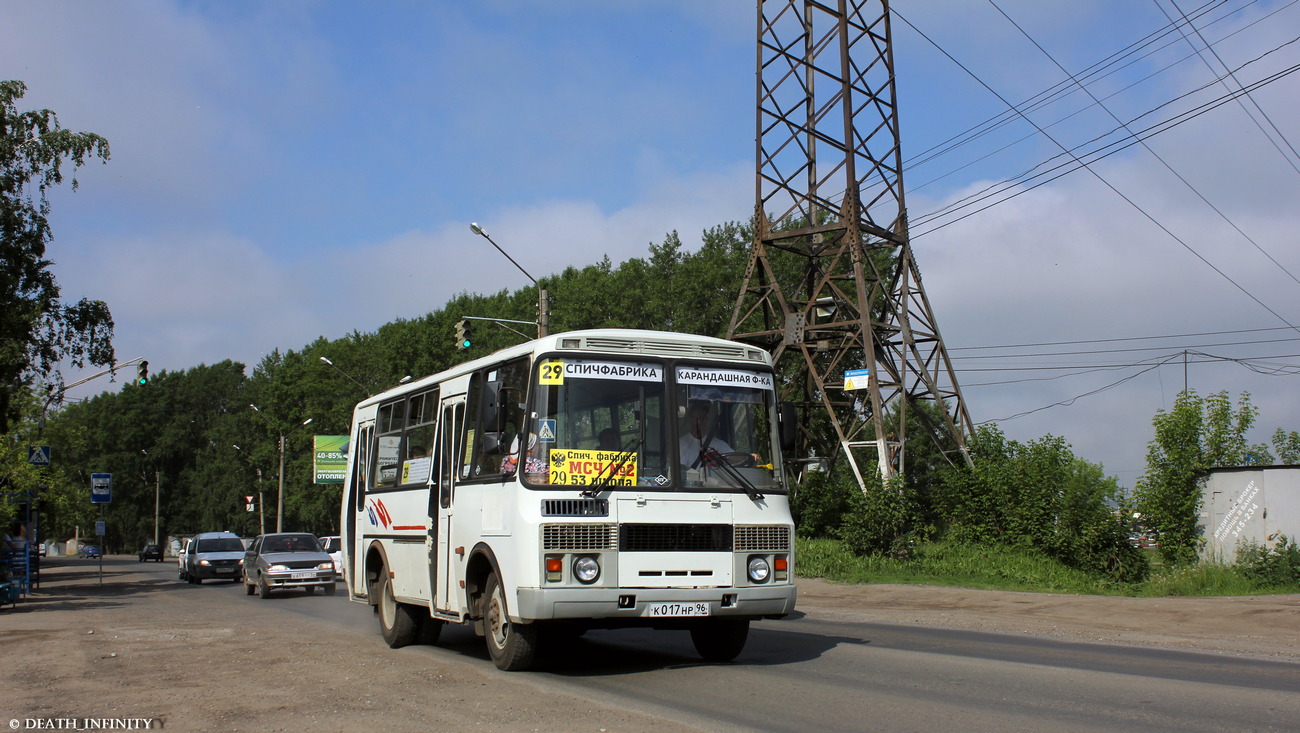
xmin=510 ymin=584 xmax=796 ymax=623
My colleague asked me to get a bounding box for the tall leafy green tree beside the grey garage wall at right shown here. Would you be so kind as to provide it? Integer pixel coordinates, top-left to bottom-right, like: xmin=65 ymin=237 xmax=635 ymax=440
xmin=1135 ymin=390 xmax=1258 ymax=563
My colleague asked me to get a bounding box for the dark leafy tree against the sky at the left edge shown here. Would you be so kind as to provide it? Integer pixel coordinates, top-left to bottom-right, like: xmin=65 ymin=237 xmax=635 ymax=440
xmin=0 ymin=81 xmax=113 ymax=433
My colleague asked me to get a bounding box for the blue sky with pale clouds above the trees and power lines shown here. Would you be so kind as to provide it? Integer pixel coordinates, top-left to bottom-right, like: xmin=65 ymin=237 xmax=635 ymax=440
xmin=0 ymin=0 xmax=1300 ymax=485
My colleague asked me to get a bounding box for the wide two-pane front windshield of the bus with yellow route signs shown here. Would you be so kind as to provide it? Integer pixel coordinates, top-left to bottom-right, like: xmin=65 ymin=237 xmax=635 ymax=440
xmin=507 ymin=357 xmax=783 ymax=495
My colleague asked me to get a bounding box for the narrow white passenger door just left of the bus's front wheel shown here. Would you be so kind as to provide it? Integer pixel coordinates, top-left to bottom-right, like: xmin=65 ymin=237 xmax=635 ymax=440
xmin=429 ymin=395 xmax=465 ymax=617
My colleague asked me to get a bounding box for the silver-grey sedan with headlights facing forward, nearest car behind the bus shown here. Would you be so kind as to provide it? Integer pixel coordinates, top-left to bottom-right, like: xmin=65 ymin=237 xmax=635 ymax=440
xmin=243 ymin=532 xmax=335 ymax=598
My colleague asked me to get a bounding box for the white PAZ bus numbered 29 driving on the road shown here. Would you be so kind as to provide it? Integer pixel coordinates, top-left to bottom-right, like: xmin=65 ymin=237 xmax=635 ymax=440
xmin=341 ymin=329 xmax=796 ymax=669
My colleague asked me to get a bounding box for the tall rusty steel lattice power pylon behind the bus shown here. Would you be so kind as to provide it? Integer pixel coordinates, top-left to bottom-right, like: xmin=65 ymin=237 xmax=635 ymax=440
xmin=728 ymin=0 xmax=972 ymax=487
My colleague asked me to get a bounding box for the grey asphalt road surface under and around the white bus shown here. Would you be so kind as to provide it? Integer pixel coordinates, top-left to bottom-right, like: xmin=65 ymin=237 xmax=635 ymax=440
xmin=109 ymin=563 xmax=1300 ymax=732
